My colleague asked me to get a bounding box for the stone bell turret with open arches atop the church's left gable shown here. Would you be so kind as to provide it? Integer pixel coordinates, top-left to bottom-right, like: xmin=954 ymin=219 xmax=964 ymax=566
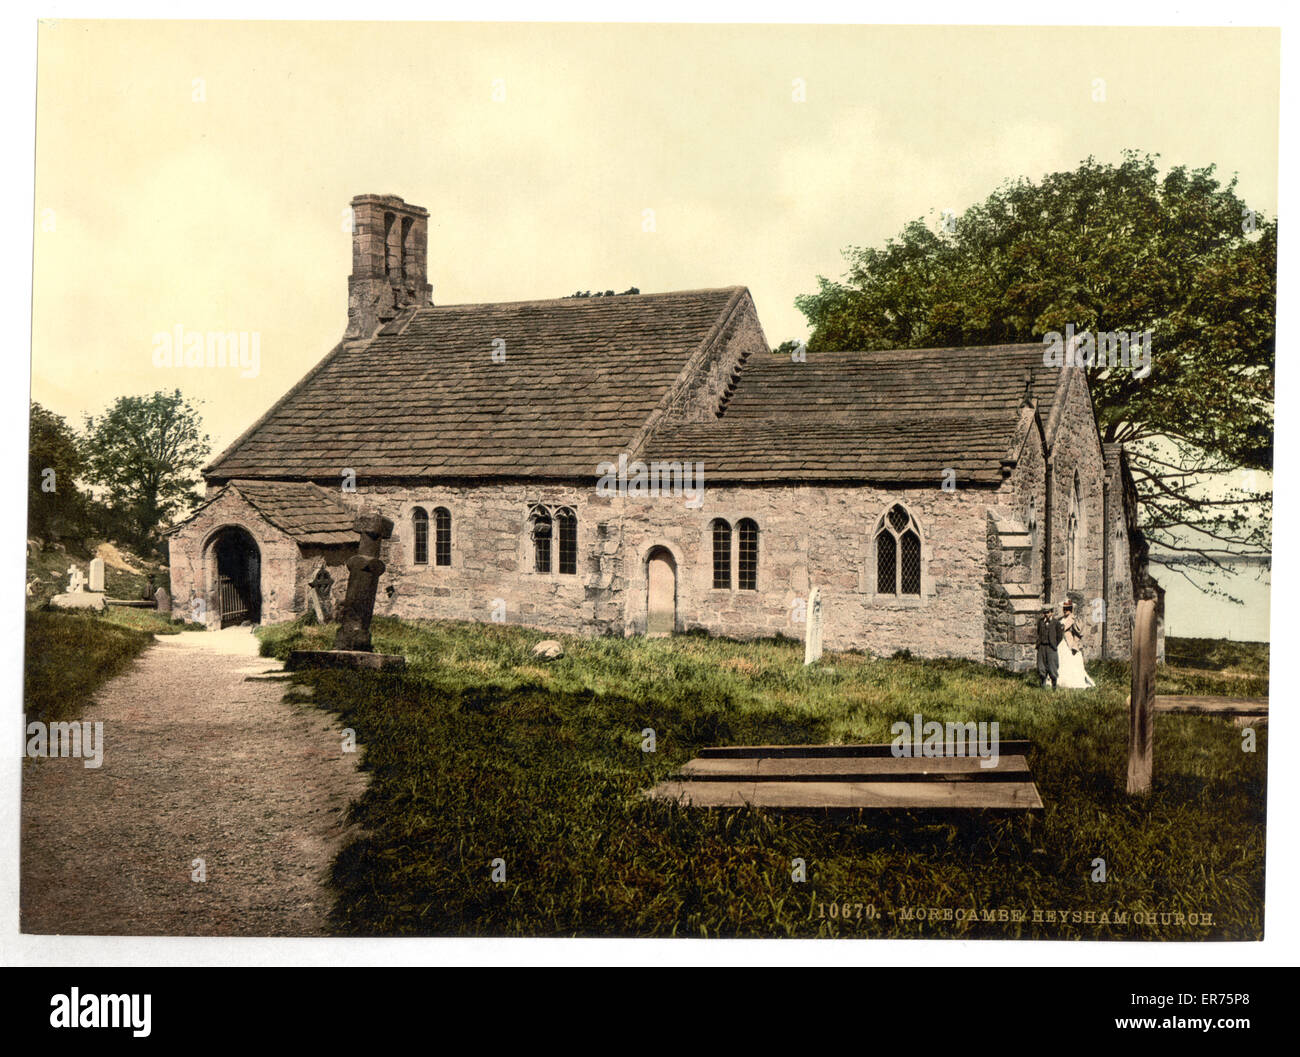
xmin=345 ymin=195 xmax=433 ymax=338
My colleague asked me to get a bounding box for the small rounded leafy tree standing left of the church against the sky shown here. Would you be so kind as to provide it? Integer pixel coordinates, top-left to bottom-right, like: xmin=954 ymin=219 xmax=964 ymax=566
xmin=85 ymin=389 xmax=209 ymax=545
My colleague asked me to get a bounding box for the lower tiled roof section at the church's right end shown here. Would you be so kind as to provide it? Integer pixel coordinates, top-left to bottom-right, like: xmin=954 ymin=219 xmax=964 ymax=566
xmin=640 ymin=343 xmax=1061 ymax=484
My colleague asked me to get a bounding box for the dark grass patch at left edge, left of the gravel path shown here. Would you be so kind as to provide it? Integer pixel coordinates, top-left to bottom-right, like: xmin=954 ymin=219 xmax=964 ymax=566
xmin=22 ymin=610 xmax=153 ymax=723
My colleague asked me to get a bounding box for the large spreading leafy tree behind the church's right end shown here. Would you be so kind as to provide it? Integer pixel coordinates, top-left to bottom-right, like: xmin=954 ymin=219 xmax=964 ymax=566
xmin=796 ymin=151 xmax=1278 ymax=582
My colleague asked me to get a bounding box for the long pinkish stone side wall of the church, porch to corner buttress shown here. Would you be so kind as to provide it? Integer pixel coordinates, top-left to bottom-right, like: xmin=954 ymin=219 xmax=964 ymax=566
xmin=340 ymin=481 xmax=996 ymax=660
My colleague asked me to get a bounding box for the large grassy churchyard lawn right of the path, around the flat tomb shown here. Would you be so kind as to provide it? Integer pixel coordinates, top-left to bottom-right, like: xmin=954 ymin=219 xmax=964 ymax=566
xmin=259 ymin=620 xmax=1268 ymax=940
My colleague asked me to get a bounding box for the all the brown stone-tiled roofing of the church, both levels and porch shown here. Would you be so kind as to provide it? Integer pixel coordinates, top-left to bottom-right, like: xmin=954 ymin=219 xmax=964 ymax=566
xmin=207 ymin=286 xmax=1061 ymax=486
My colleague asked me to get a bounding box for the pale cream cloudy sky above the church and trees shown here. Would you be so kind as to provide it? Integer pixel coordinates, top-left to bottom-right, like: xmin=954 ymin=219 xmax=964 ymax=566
xmin=33 ymin=21 xmax=1279 ymax=452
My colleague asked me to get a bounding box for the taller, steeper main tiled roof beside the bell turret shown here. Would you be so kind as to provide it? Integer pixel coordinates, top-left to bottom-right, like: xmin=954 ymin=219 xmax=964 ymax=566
xmin=205 ymin=287 xmax=745 ymax=480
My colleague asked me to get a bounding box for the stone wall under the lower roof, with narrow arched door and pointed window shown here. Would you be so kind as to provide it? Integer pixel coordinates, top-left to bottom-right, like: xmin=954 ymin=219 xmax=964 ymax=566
xmin=624 ymin=480 xmax=993 ymax=660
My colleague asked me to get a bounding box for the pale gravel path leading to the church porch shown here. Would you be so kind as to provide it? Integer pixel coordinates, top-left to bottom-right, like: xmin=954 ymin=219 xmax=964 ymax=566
xmin=21 ymin=628 xmax=365 ymax=936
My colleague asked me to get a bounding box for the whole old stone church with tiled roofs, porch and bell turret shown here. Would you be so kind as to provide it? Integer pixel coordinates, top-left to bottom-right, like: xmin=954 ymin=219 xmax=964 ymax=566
xmin=169 ymin=195 xmax=1145 ymax=670
